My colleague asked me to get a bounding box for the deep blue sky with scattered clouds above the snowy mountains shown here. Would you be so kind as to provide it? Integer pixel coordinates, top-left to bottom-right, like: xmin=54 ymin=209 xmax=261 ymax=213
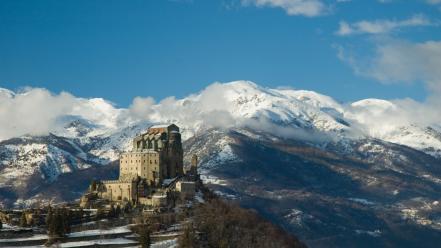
xmin=0 ymin=0 xmax=441 ymax=106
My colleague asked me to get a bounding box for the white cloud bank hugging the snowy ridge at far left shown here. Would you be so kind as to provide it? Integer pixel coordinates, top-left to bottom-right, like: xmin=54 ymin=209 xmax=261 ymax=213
xmin=0 ymin=87 xmax=132 ymax=140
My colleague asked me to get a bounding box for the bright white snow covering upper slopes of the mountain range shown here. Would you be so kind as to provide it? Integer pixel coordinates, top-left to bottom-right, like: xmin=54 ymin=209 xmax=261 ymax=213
xmin=0 ymin=81 xmax=441 ymax=189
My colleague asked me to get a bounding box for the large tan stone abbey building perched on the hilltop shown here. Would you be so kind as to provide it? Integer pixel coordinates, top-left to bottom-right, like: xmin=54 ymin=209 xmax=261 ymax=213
xmin=86 ymin=124 xmax=197 ymax=206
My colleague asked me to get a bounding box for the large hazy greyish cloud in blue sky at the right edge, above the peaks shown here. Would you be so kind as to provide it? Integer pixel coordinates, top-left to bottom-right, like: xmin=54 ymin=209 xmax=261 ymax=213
xmin=337 ymin=39 xmax=441 ymax=90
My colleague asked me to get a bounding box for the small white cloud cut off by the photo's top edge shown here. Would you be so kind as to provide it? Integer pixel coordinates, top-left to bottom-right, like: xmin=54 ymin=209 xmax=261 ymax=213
xmin=242 ymin=0 xmax=329 ymax=17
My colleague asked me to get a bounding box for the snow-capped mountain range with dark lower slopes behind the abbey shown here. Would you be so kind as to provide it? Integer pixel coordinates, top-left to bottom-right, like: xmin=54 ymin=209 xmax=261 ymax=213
xmin=0 ymin=82 xmax=441 ymax=247
